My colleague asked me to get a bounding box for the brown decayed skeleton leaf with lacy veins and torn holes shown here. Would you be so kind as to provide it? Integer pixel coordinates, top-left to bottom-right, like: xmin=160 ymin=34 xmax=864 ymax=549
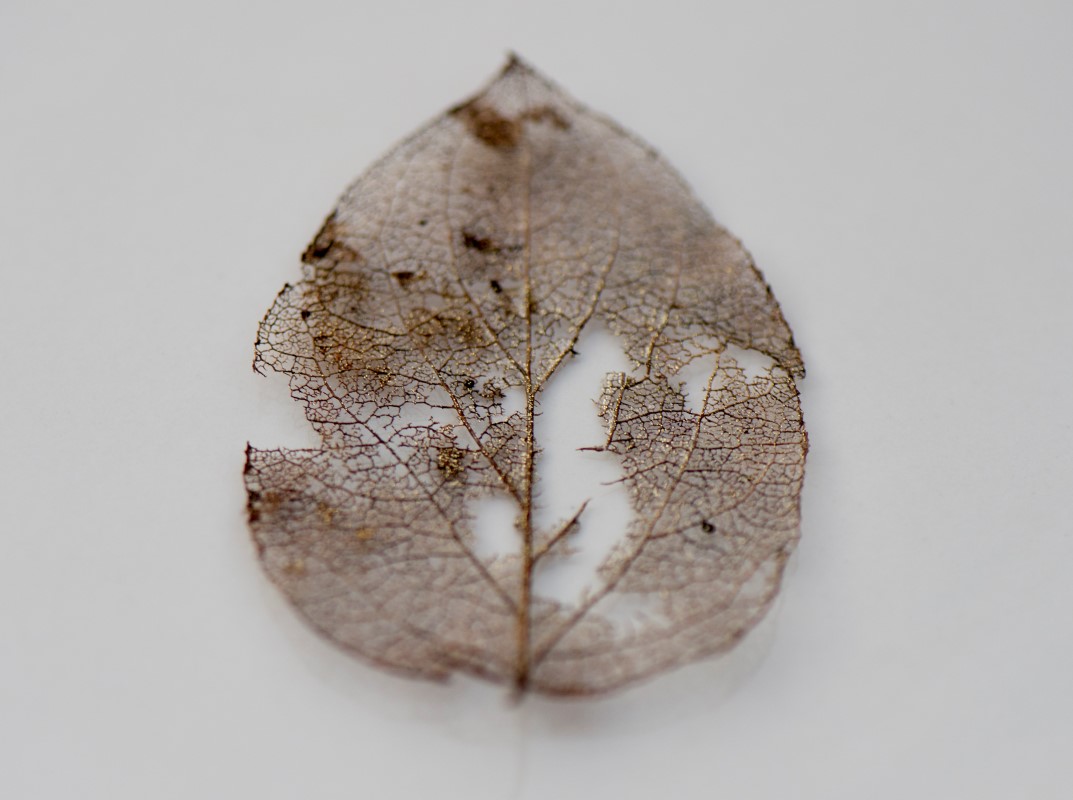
xmin=246 ymin=59 xmax=807 ymax=694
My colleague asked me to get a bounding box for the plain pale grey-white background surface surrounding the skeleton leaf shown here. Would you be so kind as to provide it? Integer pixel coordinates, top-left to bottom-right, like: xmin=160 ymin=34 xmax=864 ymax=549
xmin=0 ymin=0 xmax=1073 ymax=800
